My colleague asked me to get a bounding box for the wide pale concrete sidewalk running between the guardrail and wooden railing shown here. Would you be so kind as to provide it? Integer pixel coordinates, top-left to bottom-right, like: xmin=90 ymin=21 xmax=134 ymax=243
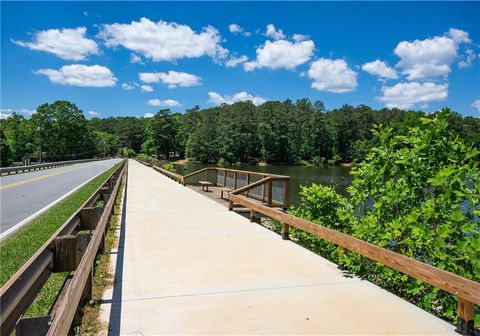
xmin=102 ymin=160 xmax=457 ymax=335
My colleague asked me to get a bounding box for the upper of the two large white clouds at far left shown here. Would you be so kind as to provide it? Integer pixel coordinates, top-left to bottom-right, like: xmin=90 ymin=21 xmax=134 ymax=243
xmin=12 ymin=27 xmax=98 ymax=61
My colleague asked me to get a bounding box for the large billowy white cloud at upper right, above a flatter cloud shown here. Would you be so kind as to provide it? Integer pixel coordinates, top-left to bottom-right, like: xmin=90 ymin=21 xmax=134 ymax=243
xmin=394 ymin=28 xmax=471 ymax=80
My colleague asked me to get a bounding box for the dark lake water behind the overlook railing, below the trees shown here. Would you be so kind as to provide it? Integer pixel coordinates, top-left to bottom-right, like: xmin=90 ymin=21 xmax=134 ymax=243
xmin=175 ymin=163 xmax=352 ymax=204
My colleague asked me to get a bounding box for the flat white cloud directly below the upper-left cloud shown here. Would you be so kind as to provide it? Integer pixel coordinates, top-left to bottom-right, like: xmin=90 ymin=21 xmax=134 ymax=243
xmin=35 ymin=64 xmax=117 ymax=87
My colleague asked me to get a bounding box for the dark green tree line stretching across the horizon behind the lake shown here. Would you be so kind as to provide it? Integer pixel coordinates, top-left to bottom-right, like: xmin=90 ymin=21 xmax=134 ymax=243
xmin=0 ymin=99 xmax=480 ymax=166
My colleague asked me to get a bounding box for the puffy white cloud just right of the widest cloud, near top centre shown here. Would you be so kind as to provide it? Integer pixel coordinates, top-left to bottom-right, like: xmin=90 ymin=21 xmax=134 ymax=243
xmin=243 ymin=40 xmax=315 ymax=71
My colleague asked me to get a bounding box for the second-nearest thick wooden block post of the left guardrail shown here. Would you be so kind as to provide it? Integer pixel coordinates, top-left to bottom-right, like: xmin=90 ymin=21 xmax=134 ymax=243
xmin=53 ymin=235 xmax=78 ymax=272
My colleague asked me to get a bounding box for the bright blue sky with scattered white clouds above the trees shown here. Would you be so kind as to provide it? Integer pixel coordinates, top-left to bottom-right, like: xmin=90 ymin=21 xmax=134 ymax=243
xmin=1 ymin=2 xmax=480 ymax=117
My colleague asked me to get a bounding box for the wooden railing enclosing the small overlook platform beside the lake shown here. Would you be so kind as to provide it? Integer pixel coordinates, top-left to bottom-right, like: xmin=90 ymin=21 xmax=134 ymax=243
xmin=183 ymin=167 xmax=290 ymax=209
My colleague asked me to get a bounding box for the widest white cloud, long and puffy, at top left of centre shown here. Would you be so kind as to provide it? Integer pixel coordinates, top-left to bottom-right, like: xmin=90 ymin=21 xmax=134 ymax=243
xmin=99 ymin=18 xmax=228 ymax=61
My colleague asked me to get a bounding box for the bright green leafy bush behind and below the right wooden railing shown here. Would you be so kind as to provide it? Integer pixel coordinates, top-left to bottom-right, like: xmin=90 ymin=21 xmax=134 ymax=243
xmin=292 ymin=109 xmax=480 ymax=322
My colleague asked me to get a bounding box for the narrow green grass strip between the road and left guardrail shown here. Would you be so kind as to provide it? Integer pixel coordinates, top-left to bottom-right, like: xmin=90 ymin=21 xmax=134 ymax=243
xmin=0 ymin=164 xmax=120 ymax=286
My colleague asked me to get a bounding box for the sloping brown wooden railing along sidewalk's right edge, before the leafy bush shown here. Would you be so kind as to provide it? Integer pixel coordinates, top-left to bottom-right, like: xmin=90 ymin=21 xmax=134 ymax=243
xmin=229 ymin=192 xmax=480 ymax=335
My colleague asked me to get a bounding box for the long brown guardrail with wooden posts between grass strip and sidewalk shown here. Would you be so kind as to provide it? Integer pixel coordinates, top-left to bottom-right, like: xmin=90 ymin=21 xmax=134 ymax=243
xmin=0 ymin=160 xmax=127 ymax=335
